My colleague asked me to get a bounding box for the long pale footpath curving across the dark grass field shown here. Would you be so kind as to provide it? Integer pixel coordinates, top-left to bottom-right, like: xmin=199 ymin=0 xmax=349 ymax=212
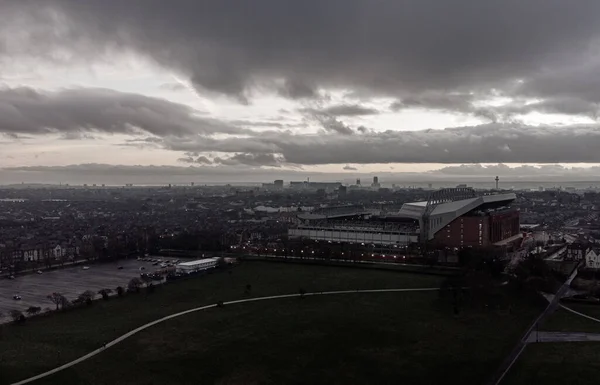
xmin=12 ymin=287 xmax=440 ymax=385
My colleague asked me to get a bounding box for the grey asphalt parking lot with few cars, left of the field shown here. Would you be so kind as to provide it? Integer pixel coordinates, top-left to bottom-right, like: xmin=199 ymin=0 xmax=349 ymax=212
xmin=0 ymin=260 xmax=171 ymax=322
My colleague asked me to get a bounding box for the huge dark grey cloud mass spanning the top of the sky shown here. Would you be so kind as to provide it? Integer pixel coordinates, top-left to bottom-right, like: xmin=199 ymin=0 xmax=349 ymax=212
xmin=0 ymin=0 xmax=600 ymax=100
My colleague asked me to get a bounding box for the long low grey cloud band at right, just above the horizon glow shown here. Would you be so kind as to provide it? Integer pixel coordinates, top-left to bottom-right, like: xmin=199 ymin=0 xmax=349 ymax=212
xmin=156 ymin=123 xmax=600 ymax=165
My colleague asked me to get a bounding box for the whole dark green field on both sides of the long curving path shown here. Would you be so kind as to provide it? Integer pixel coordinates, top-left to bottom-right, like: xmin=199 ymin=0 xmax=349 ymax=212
xmin=0 ymin=262 xmax=539 ymax=384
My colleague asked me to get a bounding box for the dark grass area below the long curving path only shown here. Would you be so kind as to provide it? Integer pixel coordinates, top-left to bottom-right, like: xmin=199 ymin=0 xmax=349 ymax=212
xmin=29 ymin=292 xmax=540 ymax=385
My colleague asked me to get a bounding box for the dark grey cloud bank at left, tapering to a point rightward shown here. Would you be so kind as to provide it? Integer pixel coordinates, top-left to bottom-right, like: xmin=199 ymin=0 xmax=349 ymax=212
xmin=0 ymin=88 xmax=244 ymax=138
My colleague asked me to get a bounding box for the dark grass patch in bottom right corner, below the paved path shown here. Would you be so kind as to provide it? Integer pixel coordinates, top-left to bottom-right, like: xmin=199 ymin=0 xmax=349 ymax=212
xmin=502 ymin=342 xmax=600 ymax=385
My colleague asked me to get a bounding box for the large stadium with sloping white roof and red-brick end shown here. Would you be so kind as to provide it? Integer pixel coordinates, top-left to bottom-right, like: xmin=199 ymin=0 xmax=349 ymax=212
xmin=288 ymin=188 xmax=522 ymax=248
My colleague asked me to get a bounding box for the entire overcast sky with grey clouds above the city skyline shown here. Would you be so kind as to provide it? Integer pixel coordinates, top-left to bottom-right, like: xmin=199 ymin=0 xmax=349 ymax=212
xmin=0 ymin=0 xmax=600 ymax=183
